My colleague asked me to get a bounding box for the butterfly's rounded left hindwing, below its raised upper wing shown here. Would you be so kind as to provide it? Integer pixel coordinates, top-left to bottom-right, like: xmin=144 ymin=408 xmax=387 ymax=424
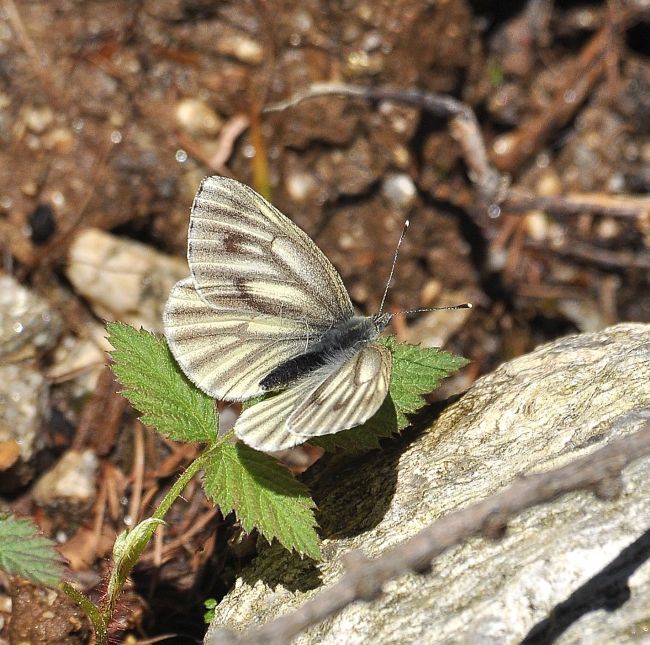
xmin=164 ymin=278 xmax=309 ymax=401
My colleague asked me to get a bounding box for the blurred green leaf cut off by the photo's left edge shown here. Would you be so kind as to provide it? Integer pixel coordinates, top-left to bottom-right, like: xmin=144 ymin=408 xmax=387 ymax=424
xmin=0 ymin=515 xmax=63 ymax=587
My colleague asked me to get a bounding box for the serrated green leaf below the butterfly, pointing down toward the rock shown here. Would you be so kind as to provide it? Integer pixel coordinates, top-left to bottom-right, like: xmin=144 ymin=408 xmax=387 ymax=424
xmin=203 ymin=443 xmax=320 ymax=559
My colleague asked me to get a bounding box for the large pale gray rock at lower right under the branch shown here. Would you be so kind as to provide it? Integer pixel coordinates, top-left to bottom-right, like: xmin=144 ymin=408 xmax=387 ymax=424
xmin=206 ymin=324 xmax=650 ymax=645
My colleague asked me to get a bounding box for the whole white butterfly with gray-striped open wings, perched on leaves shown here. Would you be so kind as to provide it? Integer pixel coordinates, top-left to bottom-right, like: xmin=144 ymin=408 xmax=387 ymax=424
xmin=164 ymin=177 xmax=392 ymax=451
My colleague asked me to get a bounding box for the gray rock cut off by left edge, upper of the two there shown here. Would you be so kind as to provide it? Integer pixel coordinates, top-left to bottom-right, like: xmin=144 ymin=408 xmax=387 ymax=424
xmin=0 ymin=274 xmax=62 ymax=363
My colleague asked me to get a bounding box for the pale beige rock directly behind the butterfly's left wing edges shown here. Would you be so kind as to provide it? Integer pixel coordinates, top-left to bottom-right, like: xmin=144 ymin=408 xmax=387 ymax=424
xmin=66 ymin=228 xmax=189 ymax=332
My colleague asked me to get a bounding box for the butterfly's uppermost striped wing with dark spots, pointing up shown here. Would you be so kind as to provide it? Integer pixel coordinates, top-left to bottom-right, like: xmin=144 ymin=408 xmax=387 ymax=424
xmin=188 ymin=177 xmax=353 ymax=330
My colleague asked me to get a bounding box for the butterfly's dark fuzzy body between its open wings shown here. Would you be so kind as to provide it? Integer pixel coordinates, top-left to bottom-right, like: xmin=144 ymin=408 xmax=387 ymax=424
xmin=260 ymin=316 xmax=378 ymax=392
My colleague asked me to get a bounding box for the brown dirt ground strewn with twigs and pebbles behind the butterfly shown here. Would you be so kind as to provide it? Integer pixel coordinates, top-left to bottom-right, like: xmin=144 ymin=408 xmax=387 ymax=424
xmin=0 ymin=0 xmax=650 ymax=643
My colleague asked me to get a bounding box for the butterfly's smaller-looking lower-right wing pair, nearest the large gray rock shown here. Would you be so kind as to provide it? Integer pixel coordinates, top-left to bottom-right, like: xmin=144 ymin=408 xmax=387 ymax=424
xmin=235 ymin=343 xmax=392 ymax=452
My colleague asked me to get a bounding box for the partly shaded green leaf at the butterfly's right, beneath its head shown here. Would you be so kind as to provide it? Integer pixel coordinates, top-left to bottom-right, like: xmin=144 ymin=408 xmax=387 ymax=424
xmin=309 ymin=336 xmax=469 ymax=451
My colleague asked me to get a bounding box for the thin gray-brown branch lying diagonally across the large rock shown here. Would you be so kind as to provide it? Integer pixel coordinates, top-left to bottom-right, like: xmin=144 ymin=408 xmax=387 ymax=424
xmin=206 ymin=422 xmax=650 ymax=645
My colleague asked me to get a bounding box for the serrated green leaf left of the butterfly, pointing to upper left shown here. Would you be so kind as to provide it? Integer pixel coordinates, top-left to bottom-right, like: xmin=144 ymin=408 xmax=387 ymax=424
xmin=106 ymin=323 xmax=218 ymax=443
